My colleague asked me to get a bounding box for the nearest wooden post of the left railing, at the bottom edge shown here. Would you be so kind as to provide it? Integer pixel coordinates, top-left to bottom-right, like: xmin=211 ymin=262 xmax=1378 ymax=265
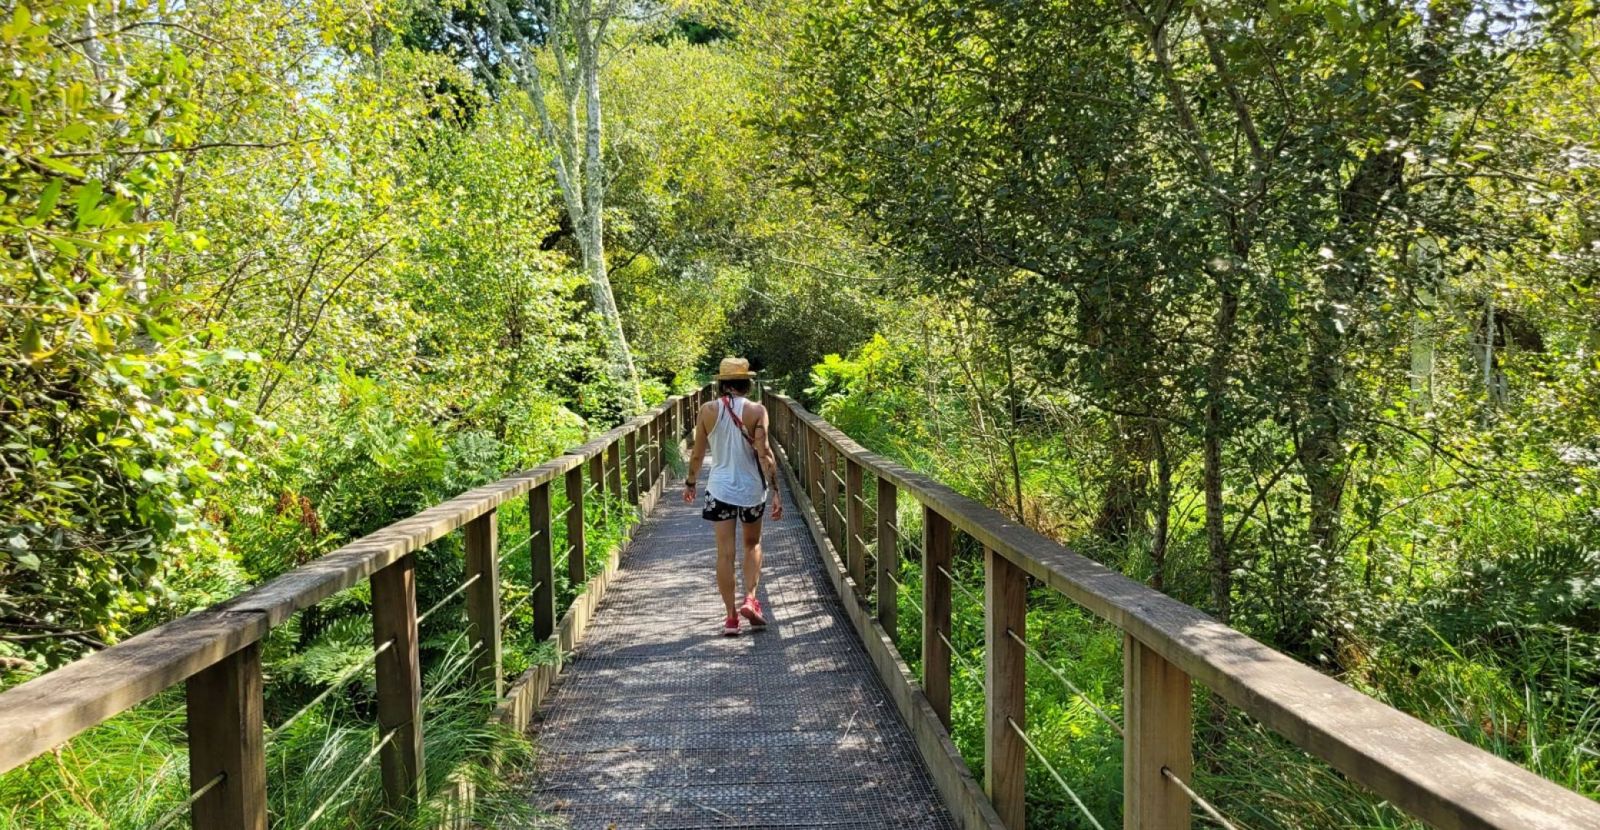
xmin=184 ymin=643 xmax=267 ymax=830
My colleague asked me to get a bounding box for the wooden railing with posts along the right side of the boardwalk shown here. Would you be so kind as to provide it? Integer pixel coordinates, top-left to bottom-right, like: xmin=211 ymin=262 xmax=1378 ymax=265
xmin=765 ymin=393 xmax=1600 ymax=830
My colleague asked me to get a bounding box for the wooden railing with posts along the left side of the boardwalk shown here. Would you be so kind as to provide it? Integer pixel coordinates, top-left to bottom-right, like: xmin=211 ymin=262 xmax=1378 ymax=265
xmin=0 ymin=389 xmax=707 ymax=830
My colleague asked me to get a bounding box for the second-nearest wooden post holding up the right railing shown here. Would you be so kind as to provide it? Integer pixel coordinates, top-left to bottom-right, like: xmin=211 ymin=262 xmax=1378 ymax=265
xmin=984 ymin=547 xmax=1027 ymax=830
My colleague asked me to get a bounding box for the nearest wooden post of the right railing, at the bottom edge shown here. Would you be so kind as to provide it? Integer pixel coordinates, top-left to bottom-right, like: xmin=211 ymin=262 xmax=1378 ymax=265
xmin=1122 ymin=633 xmax=1194 ymax=830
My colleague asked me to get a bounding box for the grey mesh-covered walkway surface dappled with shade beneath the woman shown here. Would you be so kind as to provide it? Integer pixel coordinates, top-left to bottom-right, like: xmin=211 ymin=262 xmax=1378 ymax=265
xmin=531 ymin=470 xmax=954 ymax=830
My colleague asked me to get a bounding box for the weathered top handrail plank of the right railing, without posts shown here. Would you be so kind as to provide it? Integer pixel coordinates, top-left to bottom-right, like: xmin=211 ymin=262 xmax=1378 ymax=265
xmin=771 ymin=401 xmax=1600 ymax=830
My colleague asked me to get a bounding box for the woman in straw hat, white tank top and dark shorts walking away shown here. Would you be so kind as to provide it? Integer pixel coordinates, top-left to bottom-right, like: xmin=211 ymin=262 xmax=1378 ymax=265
xmin=683 ymin=357 xmax=784 ymax=636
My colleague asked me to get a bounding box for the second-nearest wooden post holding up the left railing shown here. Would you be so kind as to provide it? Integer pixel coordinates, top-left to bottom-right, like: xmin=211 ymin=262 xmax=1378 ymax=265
xmin=369 ymin=553 xmax=422 ymax=809
